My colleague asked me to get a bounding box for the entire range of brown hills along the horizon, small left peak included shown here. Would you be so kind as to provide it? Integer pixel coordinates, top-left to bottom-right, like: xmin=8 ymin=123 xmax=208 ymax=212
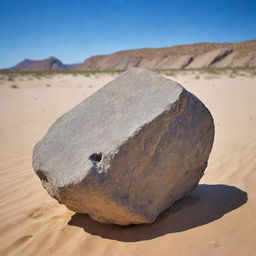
xmin=5 ymin=40 xmax=256 ymax=70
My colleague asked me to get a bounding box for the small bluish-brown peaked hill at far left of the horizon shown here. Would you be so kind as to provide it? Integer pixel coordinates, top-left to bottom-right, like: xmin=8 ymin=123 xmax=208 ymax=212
xmin=9 ymin=57 xmax=68 ymax=71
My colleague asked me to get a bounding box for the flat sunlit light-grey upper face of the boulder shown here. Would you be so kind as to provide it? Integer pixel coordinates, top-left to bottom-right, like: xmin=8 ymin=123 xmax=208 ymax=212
xmin=33 ymin=68 xmax=183 ymax=186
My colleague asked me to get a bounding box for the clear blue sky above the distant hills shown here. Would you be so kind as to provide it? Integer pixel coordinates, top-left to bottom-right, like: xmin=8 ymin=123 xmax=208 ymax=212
xmin=0 ymin=0 xmax=256 ymax=68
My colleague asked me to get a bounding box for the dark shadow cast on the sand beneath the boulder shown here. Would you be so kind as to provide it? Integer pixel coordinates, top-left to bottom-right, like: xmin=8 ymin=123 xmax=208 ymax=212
xmin=68 ymin=184 xmax=247 ymax=242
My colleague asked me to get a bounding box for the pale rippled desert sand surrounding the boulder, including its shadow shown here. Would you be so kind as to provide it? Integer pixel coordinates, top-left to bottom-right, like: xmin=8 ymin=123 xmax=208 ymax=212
xmin=0 ymin=72 xmax=256 ymax=256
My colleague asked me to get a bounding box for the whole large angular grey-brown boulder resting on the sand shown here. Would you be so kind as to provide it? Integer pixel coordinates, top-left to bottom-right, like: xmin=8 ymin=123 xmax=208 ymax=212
xmin=33 ymin=68 xmax=214 ymax=225
